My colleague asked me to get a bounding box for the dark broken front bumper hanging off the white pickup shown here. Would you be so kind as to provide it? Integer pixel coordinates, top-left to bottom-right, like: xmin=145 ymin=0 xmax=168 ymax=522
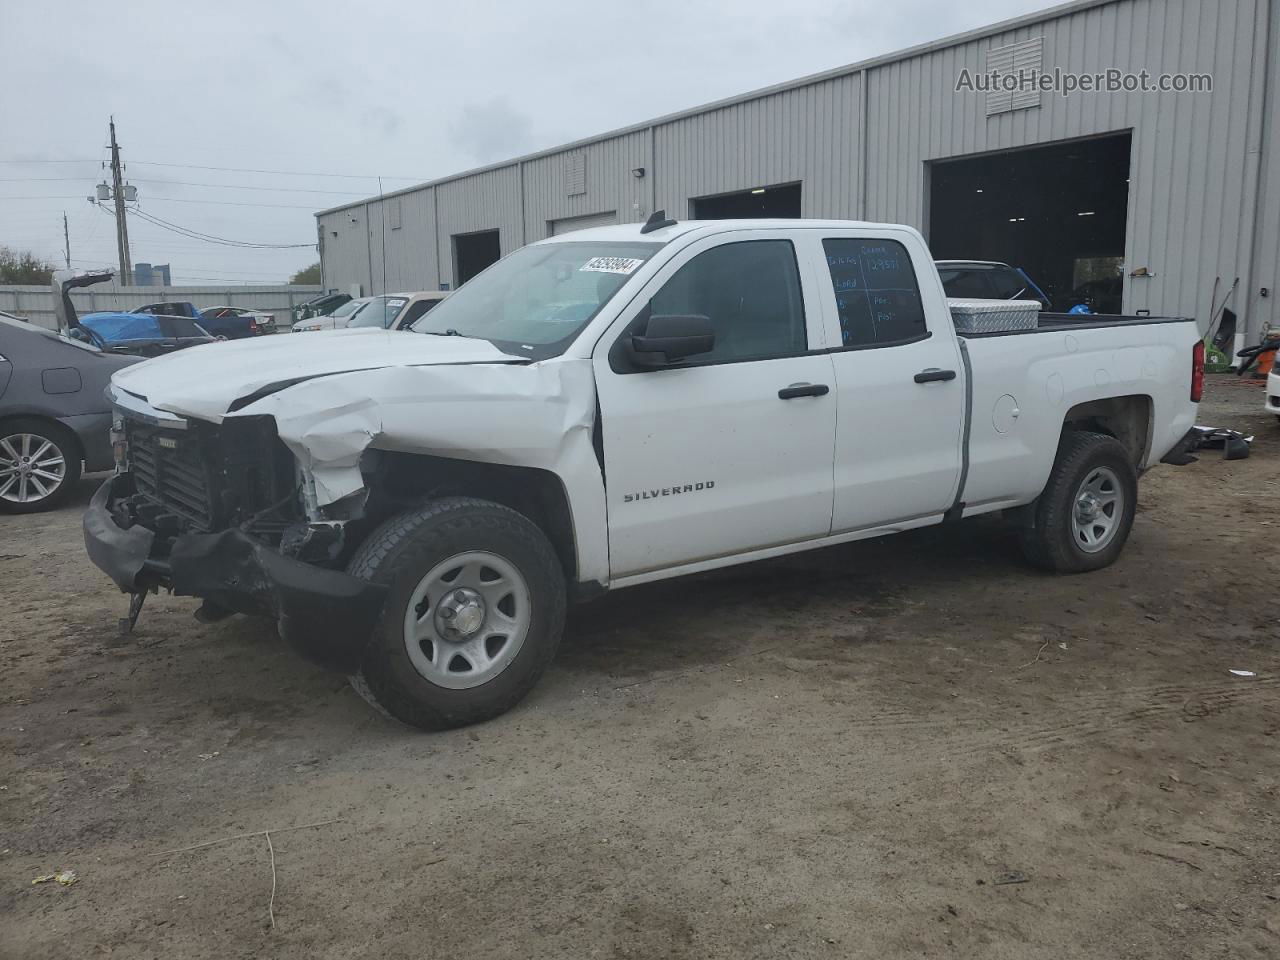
xmin=84 ymin=475 xmax=387 ymax=673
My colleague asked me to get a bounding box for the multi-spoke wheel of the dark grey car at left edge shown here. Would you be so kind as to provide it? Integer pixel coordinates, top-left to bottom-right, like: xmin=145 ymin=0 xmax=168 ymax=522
xmin=0 ymin=417 xmax=81 ymax=513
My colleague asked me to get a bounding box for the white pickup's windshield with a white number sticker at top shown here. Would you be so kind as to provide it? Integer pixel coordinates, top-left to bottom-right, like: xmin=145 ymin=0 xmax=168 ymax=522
xmin=411 ymin=241 xmax=662 ymax=360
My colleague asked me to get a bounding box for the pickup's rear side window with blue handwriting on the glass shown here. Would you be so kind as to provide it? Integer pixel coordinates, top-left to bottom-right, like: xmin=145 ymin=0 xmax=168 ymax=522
xmin=822 ymin=237 xmax=929 ymax=347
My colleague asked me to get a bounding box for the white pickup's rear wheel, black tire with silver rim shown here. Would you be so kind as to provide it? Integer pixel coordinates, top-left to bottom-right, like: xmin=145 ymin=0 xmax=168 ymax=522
xmin=1021 ymin=430 xmax=1138 ymax=573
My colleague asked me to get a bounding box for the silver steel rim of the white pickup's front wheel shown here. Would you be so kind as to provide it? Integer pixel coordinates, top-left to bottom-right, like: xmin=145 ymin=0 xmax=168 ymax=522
xmin=404 ymin=550 xmax=532 ymax=690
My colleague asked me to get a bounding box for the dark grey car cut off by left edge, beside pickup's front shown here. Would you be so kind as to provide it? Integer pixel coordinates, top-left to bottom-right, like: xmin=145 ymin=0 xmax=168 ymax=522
xmin=0 ymin=315 xmax=137 ymax=513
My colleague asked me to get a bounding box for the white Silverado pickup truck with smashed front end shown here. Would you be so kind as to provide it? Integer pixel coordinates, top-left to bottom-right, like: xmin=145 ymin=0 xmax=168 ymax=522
xmin=84 ymin=214 xmax=1202 ymax=728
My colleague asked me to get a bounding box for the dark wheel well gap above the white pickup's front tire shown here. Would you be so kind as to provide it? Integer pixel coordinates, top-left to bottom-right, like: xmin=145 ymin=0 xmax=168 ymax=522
xmin=365 ymin=451 xmax=577 ymax=582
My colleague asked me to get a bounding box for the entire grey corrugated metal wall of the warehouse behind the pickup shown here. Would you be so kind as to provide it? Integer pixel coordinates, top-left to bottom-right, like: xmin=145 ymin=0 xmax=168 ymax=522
xmin=319 ymin=0 xmax=1280 ymax=332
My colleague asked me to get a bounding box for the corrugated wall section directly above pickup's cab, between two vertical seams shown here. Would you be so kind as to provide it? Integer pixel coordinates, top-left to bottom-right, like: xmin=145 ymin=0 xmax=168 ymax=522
xmin=653 ymin=74 xmax=861 ymax=218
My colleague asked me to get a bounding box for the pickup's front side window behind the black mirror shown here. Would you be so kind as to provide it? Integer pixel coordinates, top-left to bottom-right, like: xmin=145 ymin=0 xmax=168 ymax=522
xmin=649 ymin=239 xmax=808 ymax=364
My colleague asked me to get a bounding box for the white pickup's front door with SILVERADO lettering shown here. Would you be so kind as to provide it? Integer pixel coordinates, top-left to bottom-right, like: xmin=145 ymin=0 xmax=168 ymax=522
xmin=593 ymin=230 xmax=836 ymax=580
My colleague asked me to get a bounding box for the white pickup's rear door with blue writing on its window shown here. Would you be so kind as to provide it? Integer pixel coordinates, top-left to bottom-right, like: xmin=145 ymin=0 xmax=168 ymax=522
xmin=812 ymin=229 xmax=965 ymax=534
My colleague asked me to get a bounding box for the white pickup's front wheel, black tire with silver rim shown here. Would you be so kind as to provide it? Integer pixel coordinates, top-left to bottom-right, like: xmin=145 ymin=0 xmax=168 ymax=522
xmin=347 ymin=497 xmax=566 ymax=730
